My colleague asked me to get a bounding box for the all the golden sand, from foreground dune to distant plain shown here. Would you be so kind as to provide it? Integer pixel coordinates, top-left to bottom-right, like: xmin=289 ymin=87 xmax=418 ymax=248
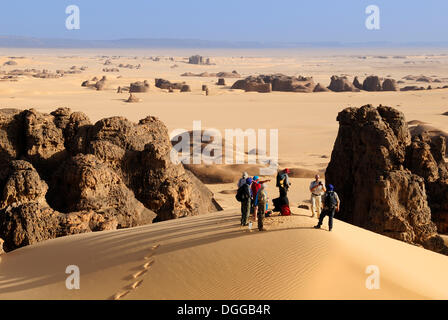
xmin=0 ymin=49 xmax=448 ymax=299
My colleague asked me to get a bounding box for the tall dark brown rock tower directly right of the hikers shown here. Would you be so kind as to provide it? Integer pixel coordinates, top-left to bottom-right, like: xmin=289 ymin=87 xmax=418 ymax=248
xmin=325 ymin=105 xmax=448 ymax=254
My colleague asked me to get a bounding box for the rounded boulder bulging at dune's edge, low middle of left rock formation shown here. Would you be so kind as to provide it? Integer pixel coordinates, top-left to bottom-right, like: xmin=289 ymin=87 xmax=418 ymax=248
xmin=52 ymin=154 xmax=156 ymax=230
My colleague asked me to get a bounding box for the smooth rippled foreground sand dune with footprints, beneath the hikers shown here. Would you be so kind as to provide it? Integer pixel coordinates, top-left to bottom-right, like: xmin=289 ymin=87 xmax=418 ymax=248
xmin=0 ymin=209 xmax=448 ymax=299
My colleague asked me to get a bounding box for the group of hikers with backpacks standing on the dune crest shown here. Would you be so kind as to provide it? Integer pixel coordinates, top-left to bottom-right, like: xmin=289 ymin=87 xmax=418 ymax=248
xmin=236 ymin=169 xmax=341 ymax=231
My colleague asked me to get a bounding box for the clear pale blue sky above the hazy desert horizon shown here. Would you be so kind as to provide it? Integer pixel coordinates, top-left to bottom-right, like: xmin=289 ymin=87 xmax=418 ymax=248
xmin=0 ymin=0 xmax=448 ymax=42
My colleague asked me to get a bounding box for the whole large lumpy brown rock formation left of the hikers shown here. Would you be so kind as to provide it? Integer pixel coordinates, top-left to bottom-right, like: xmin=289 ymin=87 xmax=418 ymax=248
xmin=0 ymin=108 xmax=220 ymax=251
